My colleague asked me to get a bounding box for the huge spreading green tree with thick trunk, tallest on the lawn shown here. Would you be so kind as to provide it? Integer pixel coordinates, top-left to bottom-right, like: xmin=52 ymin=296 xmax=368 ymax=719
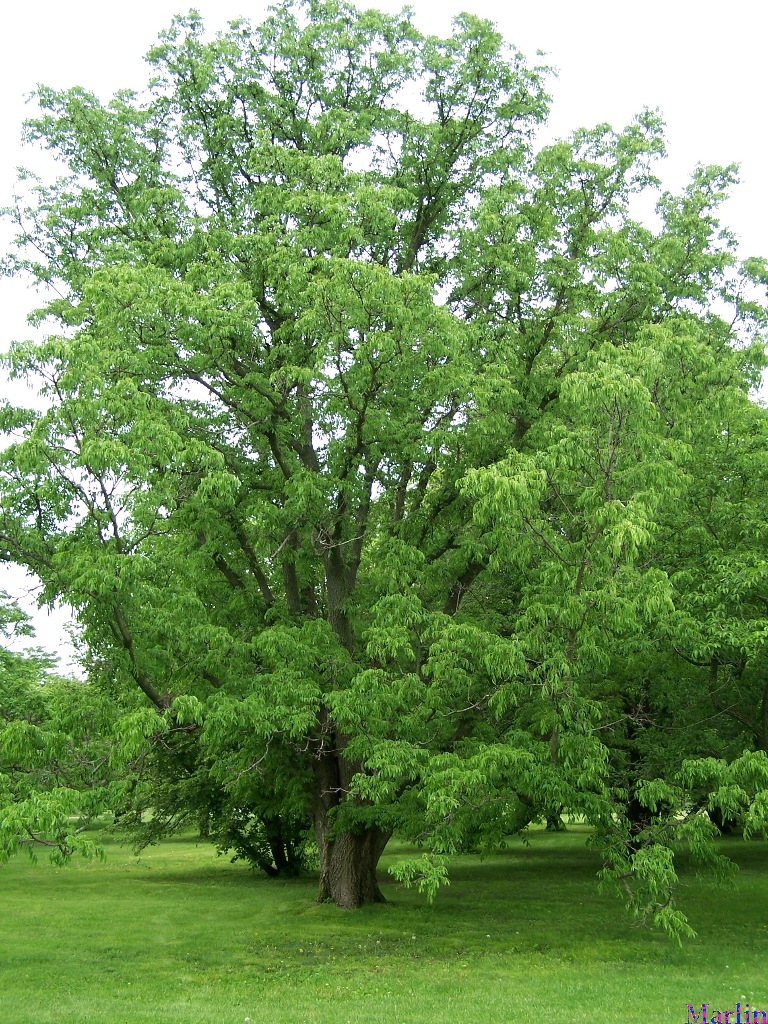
xmin=0 ymin=0 xmax=766 ymax=929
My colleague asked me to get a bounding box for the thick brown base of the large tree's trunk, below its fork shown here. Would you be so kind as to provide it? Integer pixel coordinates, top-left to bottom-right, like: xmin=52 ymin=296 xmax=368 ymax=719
xmin=317 ymin=828 xmax=389 ymax=910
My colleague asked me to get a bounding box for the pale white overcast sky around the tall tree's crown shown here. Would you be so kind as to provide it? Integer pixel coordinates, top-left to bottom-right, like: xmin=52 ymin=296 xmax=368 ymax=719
xmin=0 ymin=0 xmax=768 ymax=667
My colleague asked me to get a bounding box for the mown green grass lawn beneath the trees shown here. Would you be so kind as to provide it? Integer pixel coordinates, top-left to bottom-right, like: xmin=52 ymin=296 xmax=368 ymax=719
xmin=0 ymin=827 xmax=768 ymax=1024
